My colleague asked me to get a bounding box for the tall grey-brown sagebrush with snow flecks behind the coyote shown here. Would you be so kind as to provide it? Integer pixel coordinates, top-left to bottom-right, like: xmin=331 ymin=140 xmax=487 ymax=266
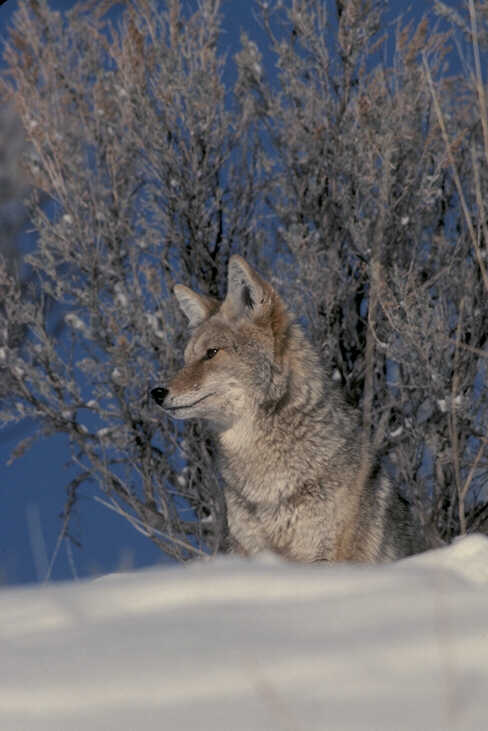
xmin=0 ymin=0 xmax=488 ymax=560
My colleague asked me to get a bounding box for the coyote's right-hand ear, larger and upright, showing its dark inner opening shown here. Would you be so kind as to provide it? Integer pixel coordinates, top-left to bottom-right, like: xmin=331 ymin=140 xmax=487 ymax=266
xmin=227 ymin=254 xmax=276 ymax=315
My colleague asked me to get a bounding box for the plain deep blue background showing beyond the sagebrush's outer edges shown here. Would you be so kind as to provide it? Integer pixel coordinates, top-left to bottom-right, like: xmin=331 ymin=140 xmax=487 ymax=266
xmin=0 ymin=0 xmax=456 ymax=585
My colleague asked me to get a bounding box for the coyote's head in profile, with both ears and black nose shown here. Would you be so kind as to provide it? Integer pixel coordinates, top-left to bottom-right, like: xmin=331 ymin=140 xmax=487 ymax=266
xmin=151 ymin=256 xmax=295 ymax=428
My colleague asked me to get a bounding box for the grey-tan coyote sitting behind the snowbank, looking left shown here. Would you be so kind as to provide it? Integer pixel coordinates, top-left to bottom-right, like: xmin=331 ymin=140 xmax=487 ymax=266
xmin=151 ymin=256 xmax=423 ymax=563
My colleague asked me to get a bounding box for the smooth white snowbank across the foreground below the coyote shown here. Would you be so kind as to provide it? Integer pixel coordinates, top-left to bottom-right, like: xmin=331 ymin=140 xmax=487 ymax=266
xmin=0 ymin=536 xmax=488 ymax=731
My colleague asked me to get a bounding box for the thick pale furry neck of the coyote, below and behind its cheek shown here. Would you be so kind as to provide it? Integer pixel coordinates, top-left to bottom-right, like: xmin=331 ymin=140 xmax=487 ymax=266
xmin=218 ymin=343 xmax=355 ymax=504
